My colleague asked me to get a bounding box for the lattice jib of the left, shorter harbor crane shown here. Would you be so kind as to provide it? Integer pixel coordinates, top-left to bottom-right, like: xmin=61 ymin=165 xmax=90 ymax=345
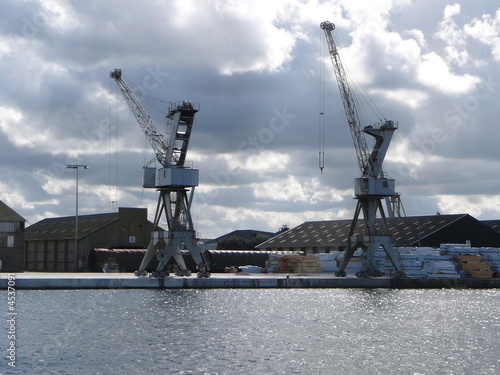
xmin=109 ymin=69 xmax=169 ymax=168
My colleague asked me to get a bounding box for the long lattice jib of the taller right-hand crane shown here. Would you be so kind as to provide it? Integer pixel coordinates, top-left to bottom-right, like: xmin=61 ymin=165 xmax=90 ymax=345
xmin=320 ymin=21 xmax=372 ymax=175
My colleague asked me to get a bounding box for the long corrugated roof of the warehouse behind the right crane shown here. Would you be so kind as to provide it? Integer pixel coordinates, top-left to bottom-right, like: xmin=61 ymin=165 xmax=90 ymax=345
xmin=257 ymin=214 xmax=467 ymax=249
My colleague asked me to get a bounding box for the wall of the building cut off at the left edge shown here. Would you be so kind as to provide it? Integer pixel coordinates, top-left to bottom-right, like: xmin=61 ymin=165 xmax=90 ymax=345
xmin=0 ymin=222 xmax=24 ymax=272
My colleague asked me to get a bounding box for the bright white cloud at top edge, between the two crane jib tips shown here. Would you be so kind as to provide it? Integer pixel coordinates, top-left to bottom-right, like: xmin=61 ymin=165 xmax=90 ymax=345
xmin=167 ymin=0 xmax=304 ymax=75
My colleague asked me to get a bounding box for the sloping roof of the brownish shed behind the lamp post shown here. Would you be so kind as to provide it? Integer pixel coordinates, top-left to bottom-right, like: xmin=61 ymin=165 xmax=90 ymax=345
xmin=26 ymin=212 xmax=118 ymax=240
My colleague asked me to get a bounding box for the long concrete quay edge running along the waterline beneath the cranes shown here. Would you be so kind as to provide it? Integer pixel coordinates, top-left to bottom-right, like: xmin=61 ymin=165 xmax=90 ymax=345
xmin=0 ymin=272 xmax=500 ymax=290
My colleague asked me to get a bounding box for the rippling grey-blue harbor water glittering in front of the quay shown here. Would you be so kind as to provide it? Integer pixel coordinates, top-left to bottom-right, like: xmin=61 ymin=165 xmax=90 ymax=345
xmin=0 ymin=289 xmax=500 ymax=375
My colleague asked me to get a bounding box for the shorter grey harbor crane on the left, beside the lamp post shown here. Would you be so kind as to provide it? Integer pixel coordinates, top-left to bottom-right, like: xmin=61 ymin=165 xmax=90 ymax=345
xmin=109 ymin=69 xmax=210 ymax=278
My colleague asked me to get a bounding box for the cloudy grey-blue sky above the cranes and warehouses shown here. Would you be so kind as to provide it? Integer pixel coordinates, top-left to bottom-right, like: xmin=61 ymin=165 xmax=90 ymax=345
xmin=0 ymin=0 xmax=500 ymax=237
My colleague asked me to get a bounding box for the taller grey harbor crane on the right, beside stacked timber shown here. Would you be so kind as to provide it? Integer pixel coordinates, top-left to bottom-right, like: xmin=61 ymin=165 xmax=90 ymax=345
xmin=320 ymin=21 xmax=404 ymax=278
